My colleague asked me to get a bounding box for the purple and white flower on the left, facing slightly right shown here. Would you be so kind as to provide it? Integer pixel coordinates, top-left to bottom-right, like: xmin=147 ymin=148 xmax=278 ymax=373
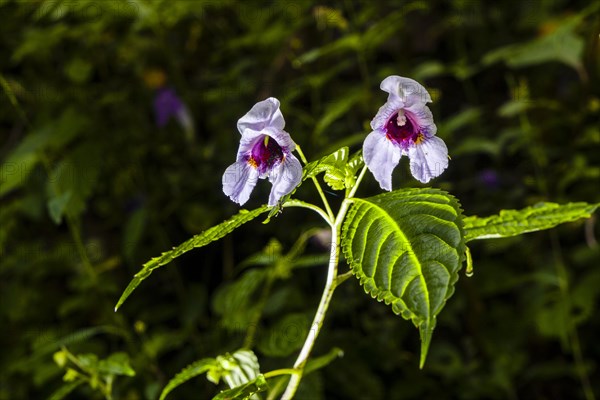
xmin=223 ymin=97 xmax=302 ymax=206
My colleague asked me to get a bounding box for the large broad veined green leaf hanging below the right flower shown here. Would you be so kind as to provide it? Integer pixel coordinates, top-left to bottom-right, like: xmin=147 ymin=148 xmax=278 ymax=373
xmin=342 ymin=189 xmax=465 ymax=367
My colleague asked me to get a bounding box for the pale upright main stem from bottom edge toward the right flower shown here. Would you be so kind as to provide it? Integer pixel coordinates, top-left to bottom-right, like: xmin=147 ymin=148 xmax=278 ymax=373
xmin=281 ymin=166 xmax=367 ymax=400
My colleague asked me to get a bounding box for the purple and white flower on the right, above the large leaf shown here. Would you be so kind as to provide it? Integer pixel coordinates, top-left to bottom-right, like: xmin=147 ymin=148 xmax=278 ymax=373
xmin=363 ymin=75 xmax=448 ymax=191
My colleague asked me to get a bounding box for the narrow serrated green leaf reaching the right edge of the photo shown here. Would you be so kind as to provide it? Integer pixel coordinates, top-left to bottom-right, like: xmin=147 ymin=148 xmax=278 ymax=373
xmin=463 ymin=203 xmax=600 ymax=241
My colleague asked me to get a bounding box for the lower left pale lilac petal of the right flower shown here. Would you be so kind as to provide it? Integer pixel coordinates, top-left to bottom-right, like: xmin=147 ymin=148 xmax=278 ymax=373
xmin=363 ymin=131 xmax=402 ymax=191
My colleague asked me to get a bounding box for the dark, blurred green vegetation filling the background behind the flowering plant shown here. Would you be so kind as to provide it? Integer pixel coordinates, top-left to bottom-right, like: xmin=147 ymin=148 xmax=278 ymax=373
xmin=0 ymin=0 xmax=600 ymax=400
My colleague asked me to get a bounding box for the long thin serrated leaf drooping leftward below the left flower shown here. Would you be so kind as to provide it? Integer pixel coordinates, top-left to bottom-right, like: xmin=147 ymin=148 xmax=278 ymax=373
xmin=115 ymin=206 xmax=270 ymax=311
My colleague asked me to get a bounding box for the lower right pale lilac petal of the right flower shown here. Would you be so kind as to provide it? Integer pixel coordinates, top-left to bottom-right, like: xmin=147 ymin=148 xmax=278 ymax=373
xmin=408 ymin=136 xmax=448 ymax=183
